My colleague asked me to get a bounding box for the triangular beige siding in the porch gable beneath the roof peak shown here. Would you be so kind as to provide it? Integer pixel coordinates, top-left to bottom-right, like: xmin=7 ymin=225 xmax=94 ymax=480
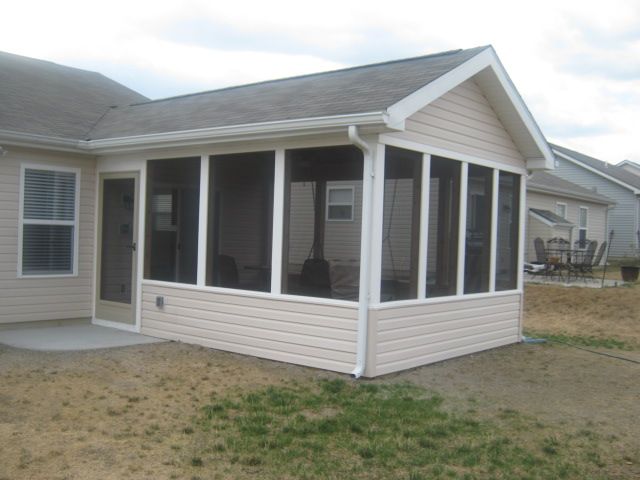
xmin=389 ymin=79 xmax=525 ymax=168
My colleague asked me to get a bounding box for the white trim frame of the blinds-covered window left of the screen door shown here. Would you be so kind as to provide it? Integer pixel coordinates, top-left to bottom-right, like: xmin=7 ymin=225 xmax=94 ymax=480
xmin=17 ymin=163 xmax=81 ymax=278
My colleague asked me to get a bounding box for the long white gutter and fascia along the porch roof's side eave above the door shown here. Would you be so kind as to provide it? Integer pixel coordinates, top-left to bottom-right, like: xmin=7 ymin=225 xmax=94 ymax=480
xmin=86 ymin=112 xmax=392 ymax=153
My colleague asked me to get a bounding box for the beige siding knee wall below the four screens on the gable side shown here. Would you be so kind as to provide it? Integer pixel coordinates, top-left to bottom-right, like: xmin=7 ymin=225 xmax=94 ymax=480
xmin=367 ymin=294 xmax=522 ymax=376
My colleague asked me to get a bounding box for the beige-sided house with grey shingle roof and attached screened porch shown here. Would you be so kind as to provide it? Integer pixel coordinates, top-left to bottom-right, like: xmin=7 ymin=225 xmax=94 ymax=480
xmin=0 ymin=47 xmax=553 ymax=377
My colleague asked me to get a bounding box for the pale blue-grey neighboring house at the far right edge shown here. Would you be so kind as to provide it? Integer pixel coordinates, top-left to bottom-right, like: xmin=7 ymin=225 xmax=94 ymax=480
xmin=551 ymin=145 xmax=640 ymax=258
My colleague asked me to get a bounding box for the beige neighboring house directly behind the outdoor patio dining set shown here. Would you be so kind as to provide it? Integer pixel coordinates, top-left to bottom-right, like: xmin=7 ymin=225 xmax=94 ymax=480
xmin=526 ymin=172 xmax=615 ymax=261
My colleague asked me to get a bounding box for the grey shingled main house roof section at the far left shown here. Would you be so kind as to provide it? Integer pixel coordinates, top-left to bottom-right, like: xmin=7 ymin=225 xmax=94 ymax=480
xmin=0 ymin=52 xmax=147 ymax=139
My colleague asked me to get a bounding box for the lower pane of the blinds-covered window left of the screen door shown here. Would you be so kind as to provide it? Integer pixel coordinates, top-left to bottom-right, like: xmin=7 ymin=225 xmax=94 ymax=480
xmin=22 ymin=224 xmax=73 ymax=275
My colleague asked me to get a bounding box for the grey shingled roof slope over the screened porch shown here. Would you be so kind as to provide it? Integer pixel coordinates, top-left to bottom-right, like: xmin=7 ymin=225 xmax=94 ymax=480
xmin=88 ymin=46 xmax=491 ymax=140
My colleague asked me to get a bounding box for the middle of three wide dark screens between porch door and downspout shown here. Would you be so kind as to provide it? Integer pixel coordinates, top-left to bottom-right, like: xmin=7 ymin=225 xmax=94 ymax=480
xmin=207 ymin=152 xmax=275 ymax=292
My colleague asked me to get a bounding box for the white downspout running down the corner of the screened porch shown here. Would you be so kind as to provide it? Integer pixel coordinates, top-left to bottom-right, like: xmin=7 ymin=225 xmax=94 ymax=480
xmin=348 ymin=125 xmax=374 ymax=378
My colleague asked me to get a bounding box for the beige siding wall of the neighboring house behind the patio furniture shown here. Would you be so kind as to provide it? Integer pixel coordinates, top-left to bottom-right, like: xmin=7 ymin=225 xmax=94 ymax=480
xmin=526 ymin=191 xmax=607 ymax=259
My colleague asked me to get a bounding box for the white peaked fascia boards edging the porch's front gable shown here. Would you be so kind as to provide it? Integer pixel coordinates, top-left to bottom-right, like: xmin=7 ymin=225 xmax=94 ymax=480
xmin=387 ymin=47 xmax=554 ymax=170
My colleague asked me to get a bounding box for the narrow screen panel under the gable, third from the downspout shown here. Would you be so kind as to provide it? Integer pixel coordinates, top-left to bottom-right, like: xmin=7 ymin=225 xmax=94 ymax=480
xmin=464 ymin=165 xmax=493 ymax=293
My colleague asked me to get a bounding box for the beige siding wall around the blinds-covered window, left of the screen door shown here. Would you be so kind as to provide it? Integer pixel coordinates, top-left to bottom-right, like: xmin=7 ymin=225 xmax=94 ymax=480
xmin=0 ymin=147 xmax=96 ymax=324
